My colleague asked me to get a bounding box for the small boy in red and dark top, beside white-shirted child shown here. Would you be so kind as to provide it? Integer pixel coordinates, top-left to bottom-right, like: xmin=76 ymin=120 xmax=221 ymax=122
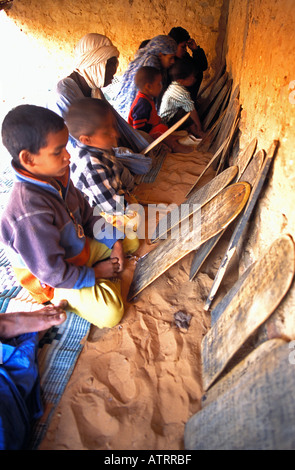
xmin=128 ymin=66 xmax=192 ymax=153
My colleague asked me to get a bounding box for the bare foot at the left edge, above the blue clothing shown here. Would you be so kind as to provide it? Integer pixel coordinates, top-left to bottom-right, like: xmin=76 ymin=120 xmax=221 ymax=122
xmin=0 ymin=304 xmax=67 ymax=339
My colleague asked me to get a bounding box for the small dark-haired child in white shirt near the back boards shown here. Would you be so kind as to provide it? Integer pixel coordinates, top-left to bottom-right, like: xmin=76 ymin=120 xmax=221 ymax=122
xmin=159 ymin=60 xmax=204 ymax=137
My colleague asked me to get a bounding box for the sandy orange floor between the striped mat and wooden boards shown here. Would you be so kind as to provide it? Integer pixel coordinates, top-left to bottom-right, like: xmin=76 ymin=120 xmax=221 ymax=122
xmin=40 ymin=141 xmax=225 ymax=450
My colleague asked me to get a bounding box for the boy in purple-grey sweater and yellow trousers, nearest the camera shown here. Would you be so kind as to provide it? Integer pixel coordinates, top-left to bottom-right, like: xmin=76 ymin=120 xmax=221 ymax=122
xmin=0 ymin=105 xmax=139 ymax=328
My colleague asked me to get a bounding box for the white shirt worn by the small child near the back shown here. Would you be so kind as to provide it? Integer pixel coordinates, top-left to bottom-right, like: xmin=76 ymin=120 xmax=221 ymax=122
xmin=159 ymin=81 xmax=195 ymax=123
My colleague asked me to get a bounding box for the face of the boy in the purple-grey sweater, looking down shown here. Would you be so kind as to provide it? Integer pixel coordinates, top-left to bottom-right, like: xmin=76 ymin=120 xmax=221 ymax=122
xmin=19 ymin=126 xmax=70 ymax=178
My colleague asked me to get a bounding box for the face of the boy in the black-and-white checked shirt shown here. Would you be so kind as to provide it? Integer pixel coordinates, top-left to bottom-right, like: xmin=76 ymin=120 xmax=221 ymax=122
xmin=84 ymin=112 xmax=119 ymax=150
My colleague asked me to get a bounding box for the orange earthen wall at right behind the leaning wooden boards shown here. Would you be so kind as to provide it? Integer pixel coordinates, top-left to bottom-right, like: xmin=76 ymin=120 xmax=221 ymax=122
xmin=224 ymin=0 xmax=295 ymax=339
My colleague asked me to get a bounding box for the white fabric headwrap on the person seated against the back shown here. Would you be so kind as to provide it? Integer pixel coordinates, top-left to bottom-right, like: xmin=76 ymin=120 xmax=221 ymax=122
xmin=74 ymin=33 xmax=119 ymax=92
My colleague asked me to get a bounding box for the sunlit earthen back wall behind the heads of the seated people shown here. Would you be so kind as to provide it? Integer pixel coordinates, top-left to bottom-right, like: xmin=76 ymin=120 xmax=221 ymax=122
xmin=0 ymin=0 xmax=224 ymax=102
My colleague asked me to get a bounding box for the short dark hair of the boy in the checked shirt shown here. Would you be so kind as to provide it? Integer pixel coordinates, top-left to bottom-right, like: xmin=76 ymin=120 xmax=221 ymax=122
xmin=65 ymin=98 xmax=112 ymax=140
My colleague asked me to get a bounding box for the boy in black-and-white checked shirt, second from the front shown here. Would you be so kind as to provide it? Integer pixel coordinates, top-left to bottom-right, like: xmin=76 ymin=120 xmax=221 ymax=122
xmin=65 ymin=98 xmax=141 ymax=233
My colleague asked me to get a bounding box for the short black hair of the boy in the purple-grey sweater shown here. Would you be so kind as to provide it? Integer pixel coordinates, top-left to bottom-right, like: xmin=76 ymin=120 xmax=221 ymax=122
xmin=1 ymin=104 xmax=65 ymax=166
